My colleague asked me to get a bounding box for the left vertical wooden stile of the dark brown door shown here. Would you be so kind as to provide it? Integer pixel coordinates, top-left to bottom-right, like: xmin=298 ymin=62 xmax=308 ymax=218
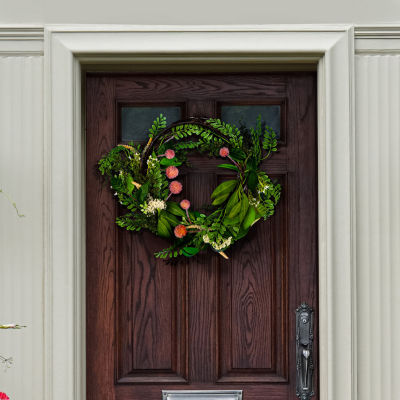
xmin=86 ymin=78 xmax=117 ymax=400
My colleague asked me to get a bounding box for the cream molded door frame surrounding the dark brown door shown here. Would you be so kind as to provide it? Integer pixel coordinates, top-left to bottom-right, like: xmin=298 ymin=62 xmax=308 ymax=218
xmin=44 ymin=25 xmax=357 ymax=400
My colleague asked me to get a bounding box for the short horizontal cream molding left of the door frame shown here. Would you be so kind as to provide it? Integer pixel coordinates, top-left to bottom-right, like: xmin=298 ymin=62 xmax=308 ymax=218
xmin=0 ymin=26 xmax=44 ymax=56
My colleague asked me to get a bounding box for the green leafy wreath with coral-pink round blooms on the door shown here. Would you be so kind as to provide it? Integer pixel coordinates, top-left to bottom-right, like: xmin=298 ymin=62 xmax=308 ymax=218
xmin=99 ymin=114 xmax=281 ymax=258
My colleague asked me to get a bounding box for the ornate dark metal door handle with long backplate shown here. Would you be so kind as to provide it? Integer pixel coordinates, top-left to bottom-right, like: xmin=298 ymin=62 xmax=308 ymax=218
xmin=296 ymin=303 xmax=314 ymax=400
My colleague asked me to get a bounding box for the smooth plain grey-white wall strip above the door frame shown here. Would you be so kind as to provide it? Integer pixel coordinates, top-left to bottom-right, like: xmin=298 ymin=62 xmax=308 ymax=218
xmin=0 ymin=0 xmax=400 ymax=25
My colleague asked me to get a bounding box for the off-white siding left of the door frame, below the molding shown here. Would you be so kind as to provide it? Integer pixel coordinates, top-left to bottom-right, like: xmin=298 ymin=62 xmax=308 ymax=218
xmin=0 ymin=53 xmax=44 ymax=400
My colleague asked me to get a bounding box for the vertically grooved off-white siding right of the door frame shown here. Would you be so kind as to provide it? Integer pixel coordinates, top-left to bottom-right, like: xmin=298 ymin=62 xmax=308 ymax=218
xmin=355 ymin=55 xmax=400 ymax=400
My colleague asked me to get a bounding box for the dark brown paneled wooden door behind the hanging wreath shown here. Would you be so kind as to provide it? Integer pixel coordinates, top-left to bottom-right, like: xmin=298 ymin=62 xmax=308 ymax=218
xmin=86 ymin=73 xmax=318 ymax=400
